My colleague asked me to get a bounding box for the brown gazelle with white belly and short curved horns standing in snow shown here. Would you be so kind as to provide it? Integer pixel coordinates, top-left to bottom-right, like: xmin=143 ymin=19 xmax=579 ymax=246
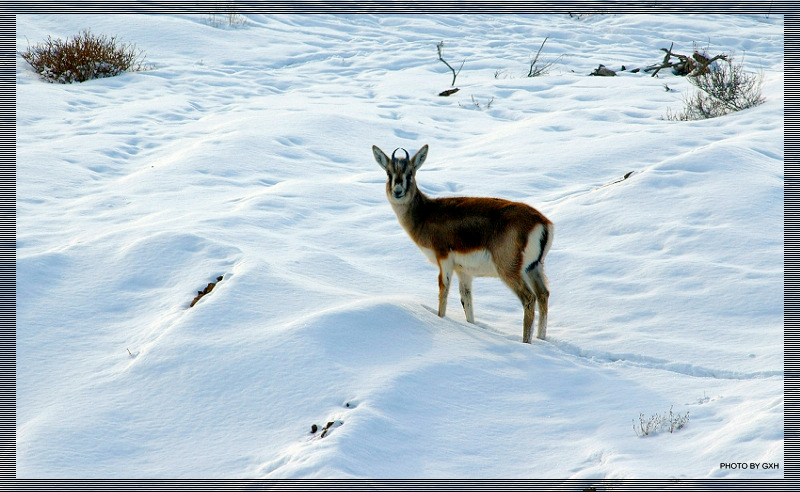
xmin=372 ymin=145 xmax=553 ymax=343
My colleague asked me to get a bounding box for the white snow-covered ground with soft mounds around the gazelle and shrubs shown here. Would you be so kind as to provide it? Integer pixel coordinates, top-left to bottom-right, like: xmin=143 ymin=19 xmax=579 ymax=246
xmin=16 ymin=15 xmax=784 ymax=479
